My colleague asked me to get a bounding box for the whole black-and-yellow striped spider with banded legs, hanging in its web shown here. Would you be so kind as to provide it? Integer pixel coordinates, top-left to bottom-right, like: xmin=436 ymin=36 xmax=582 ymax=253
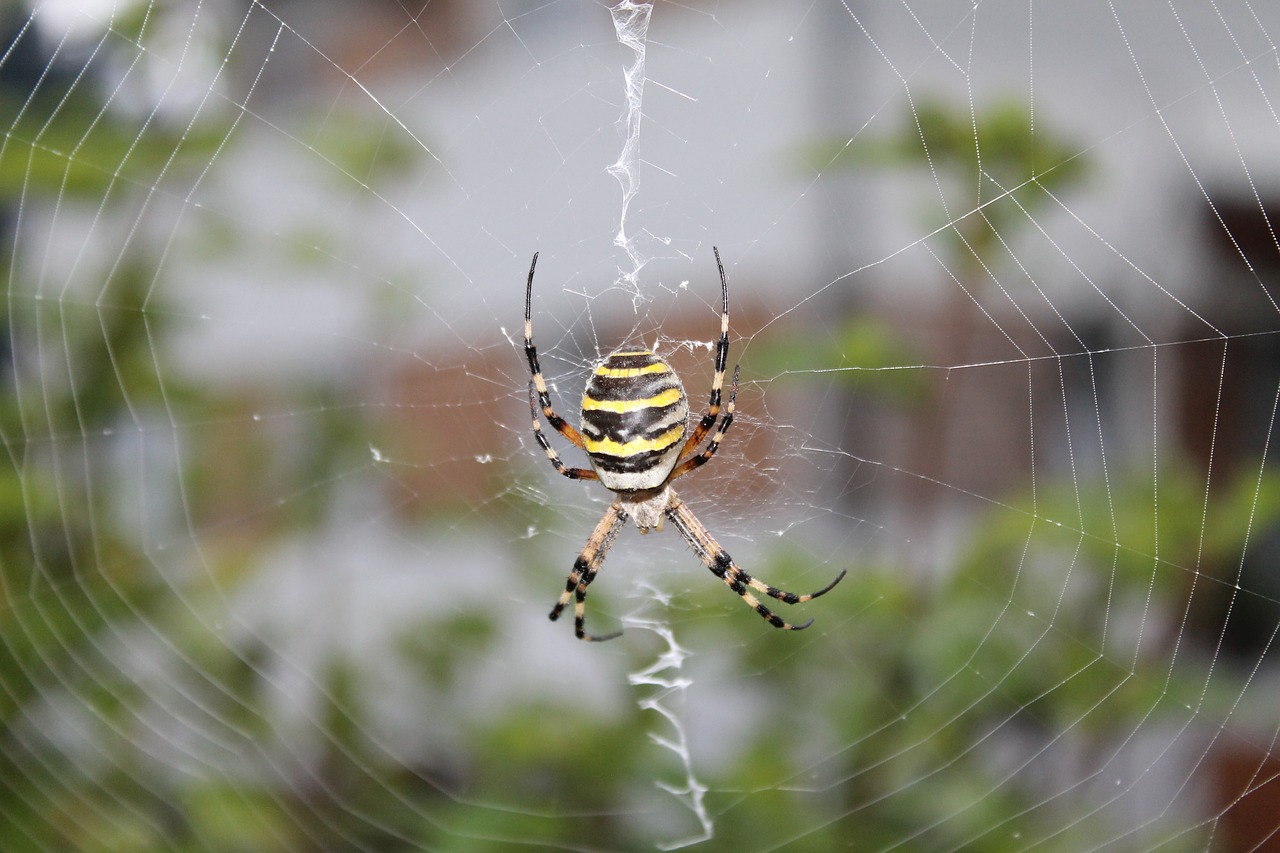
xmin=525 ymin=248 xmax=845 ymax=642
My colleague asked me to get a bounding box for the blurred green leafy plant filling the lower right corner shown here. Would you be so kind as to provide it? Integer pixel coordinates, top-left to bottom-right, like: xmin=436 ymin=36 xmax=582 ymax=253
xmin=650 ymin=455 xmax=1280 ymax=852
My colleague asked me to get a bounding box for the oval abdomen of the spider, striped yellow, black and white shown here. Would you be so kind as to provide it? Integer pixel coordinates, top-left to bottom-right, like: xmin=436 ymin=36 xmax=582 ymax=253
xmin=582 ymin=350 xmax=689 ymax=492
